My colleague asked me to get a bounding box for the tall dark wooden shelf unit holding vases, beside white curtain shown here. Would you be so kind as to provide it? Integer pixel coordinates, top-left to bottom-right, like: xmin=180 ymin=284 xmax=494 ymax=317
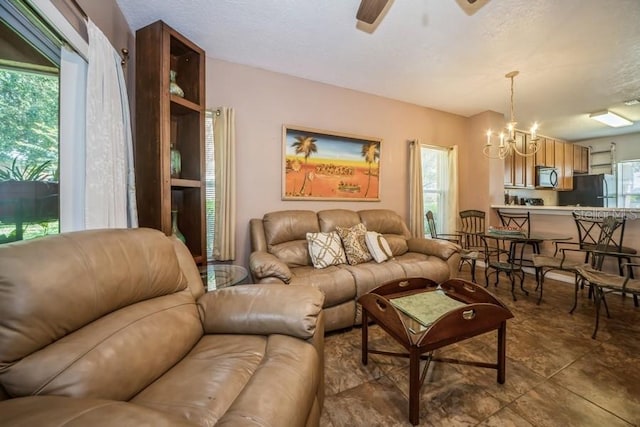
xmin=135 ymin=21 xmax=206 ymax=263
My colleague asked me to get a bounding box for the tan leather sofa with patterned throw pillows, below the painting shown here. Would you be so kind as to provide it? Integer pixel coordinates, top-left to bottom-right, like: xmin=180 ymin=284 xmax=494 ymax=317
xmin=249 ymin=209 xmax=460 ymax=331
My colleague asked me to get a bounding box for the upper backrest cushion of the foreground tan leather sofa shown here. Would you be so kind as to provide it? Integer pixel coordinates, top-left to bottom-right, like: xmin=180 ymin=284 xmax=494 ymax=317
xmin=0 ymin=228 xmax=187 ymax=366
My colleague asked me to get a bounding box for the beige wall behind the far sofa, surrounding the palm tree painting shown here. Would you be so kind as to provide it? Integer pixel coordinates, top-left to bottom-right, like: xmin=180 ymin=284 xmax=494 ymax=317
xmin=206 ymin=58 xmax=472 ymax=264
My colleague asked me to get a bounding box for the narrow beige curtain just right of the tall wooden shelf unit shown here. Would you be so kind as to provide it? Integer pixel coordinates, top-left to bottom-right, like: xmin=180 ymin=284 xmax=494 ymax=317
xmin=213 ymin=107 xmax=236 ymax=261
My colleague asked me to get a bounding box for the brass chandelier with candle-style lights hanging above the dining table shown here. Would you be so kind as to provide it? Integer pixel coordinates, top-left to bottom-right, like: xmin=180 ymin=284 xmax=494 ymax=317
xmin=482 ymin=71 xmax=540 ymax=160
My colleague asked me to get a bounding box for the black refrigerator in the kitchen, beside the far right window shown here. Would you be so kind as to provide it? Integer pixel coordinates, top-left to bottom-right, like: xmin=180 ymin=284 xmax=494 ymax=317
xmin=558 ymin=173 xmax=617 ymax=208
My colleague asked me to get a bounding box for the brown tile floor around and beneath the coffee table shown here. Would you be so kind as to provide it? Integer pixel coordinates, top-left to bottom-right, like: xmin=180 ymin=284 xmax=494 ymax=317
xmin=320 ymin=269 xmax=640 ymax=427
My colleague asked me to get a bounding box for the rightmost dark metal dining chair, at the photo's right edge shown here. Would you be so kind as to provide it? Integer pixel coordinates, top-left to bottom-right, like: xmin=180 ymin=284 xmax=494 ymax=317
xmin=571 ymin=216 xmax=640 ymax=339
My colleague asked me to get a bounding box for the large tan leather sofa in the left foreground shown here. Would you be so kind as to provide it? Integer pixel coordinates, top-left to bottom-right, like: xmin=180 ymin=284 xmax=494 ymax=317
xmin=0 ymin=229 xmax=324 ymax=427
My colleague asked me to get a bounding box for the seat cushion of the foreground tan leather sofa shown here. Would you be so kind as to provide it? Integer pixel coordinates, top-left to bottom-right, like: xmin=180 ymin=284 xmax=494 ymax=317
xmin=132 ymin=334 xmax=321 ymax=426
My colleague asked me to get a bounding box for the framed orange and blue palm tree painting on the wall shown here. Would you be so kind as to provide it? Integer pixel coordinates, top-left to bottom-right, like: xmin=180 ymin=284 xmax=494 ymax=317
xmin=282 ymin=125 xmax=381 ymax=201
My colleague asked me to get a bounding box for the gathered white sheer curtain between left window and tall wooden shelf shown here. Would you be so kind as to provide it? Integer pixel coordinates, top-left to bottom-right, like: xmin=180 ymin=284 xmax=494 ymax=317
xmin=85 ymin=20 xmax=138 ymax=229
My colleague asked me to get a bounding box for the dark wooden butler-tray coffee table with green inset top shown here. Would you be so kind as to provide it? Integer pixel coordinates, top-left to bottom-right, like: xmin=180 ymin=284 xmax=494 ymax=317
xmin=358 ymin=278 xmax=513 ymax=425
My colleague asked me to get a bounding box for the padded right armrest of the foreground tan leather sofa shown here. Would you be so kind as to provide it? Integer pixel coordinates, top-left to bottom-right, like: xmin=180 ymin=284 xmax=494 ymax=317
xmin=198 ymin=285 xmax=324 ymax=339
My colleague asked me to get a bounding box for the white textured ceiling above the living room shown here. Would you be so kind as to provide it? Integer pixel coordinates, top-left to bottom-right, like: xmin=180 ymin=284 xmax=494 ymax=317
xmin=117 ymin=0 xmax=640 ymax=141
